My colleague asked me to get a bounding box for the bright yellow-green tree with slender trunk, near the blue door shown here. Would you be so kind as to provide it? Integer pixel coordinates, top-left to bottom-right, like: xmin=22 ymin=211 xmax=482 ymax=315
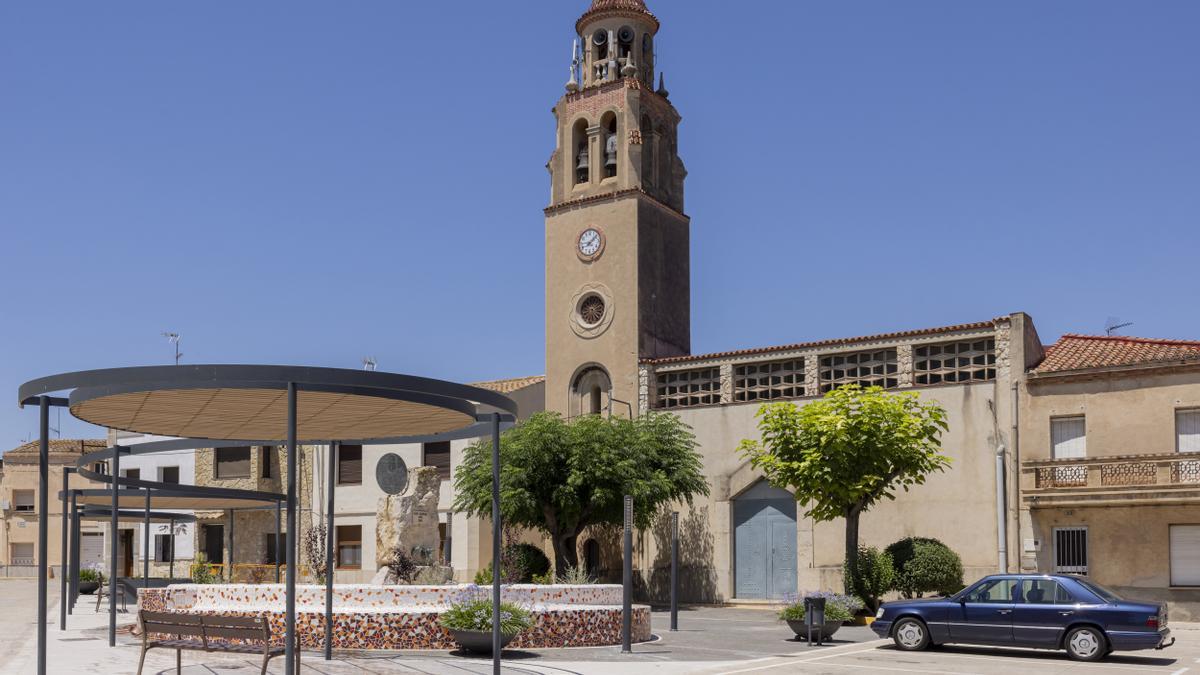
xmin=739 ymin=384 xmax=950 ymax=610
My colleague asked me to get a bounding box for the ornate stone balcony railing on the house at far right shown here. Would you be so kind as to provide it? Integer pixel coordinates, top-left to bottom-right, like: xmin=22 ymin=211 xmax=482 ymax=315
xmin=1021 ymin=453 xmax=1200 ymax=491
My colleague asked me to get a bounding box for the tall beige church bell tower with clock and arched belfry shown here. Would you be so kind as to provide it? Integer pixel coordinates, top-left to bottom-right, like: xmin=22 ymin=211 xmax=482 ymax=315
xmin=545 ymin=0 xmax=691 ymax=417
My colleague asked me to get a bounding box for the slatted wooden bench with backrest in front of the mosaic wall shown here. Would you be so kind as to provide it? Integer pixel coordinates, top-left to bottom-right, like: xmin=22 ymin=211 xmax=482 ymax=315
xmin=138 ymin=610 xmax=300 ymax=675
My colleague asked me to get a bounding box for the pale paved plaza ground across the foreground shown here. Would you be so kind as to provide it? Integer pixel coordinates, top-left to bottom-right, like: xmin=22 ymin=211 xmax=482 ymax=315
xmin=0 ymin=580 xmax=1200 ymax=675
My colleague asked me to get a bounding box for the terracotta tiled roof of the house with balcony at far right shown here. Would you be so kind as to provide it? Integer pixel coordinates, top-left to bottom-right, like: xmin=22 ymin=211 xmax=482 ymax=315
xmin=1033 ymin=333 xmax=1200 ymax=374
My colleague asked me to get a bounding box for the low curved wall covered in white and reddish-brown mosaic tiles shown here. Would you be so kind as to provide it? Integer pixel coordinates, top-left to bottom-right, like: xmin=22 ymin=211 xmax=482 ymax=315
xmin=138 ymin=584 xmax=650 ymax=650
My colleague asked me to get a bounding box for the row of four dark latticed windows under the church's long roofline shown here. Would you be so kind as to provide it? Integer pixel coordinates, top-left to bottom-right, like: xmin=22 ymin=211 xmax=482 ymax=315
xmin=654 ymin=338 xmax=996 ymax=408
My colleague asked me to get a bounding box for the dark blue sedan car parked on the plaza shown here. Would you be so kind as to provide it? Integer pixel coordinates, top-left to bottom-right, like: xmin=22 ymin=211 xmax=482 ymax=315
xmin=871 ymin=574 xmax=1175 ymax=661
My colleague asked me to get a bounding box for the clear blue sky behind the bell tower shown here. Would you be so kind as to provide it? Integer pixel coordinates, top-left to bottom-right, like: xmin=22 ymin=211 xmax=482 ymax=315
xmin=0 ymin=0 xmax=1200 ymax=448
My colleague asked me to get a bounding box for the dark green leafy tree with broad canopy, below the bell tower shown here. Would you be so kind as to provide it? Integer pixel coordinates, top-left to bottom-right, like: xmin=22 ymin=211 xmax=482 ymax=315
xmin=454 ymin=412 xmax=708 ymax=569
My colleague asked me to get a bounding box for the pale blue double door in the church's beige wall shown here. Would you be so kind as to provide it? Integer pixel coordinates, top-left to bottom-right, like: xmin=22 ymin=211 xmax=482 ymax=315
xmin=733 ymin=482 xmax=797 ymax=598
